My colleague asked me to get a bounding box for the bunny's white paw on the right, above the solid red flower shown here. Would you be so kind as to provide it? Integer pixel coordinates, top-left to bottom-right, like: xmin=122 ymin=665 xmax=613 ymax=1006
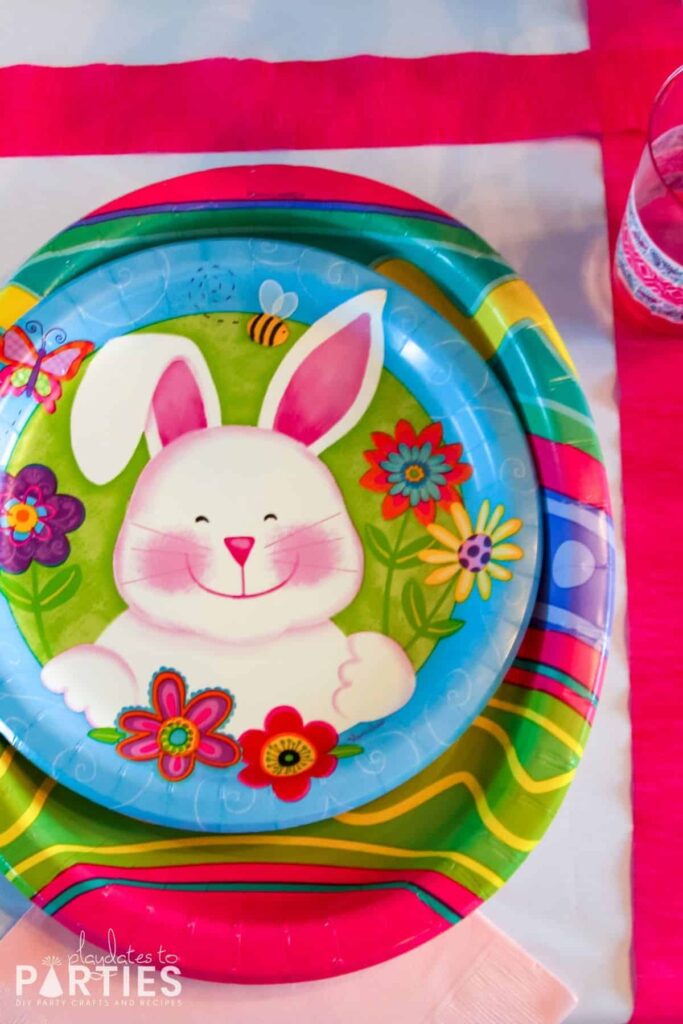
xmin=333 ymin=633 xmax=415 ymax=728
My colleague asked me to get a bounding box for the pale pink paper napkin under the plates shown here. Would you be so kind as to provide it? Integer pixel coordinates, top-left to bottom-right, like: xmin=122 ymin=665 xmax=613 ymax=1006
xmin=0 ymin=908 xmax=577 ymax=1024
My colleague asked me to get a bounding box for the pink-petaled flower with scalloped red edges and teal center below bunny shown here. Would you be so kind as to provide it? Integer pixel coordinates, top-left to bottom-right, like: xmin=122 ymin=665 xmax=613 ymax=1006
xmin=117 ymin=669 xmax=240 ymax=782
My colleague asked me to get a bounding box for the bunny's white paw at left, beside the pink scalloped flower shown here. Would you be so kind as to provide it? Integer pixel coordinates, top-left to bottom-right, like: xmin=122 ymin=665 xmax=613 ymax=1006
xmin=41 ymin=644 xmax=138 ymax=727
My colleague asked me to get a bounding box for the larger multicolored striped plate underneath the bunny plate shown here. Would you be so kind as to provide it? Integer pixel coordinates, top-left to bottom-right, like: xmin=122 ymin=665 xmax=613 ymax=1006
xmin=0 ymin=167 xmax=613 ymax=982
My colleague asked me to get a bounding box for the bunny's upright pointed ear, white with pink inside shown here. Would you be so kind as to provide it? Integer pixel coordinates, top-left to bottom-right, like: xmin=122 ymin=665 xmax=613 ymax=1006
xmin=258 ymin=289 xmax=386 ymax=454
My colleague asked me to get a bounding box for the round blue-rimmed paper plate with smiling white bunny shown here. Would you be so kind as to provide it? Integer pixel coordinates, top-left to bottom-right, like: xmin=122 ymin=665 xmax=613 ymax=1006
xmin=0 ymin=239 xmax=541 ymax=831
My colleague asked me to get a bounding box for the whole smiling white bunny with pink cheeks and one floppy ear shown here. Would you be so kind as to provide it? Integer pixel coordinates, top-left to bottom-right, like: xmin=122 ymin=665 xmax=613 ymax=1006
xmin=42 ymin=290 xmax=415 ymax=734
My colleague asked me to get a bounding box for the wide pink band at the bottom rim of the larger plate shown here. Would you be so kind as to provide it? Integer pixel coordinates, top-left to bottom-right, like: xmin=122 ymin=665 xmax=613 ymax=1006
xmin=50 ymin=882 xmax=451 ymax=983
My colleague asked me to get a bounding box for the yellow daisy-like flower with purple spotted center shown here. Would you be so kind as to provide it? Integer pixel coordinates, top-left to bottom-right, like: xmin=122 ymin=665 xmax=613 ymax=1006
xmin=419 ymin=500 xmax=524 ymax=603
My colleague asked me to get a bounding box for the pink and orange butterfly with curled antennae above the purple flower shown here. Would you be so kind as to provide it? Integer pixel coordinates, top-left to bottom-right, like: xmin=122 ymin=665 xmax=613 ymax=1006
xmin=0 ymin=321 xmax=95 ymax=413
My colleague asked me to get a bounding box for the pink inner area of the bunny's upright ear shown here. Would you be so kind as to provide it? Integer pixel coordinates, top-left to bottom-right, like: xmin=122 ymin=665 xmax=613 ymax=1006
xmin=272 ymin=313 xmax=370 ymax=444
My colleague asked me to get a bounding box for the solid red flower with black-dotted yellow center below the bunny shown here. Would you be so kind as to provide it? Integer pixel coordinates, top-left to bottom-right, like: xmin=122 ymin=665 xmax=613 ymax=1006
xmin=238 ymin=707 xmax=339 ymax=801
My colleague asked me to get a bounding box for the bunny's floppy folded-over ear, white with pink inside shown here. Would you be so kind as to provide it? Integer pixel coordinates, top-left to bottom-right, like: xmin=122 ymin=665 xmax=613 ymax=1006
xmin=71 ymin=334 xmax=220 ymax=483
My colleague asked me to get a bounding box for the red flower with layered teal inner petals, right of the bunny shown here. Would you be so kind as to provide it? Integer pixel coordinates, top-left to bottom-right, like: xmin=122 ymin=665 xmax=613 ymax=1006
xmin=360 ymin=420 xmax=472 ymax=526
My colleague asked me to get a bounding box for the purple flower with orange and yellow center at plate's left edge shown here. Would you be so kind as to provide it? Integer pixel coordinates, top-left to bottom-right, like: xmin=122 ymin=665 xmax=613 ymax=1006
xmin=0 ymin=464 xmax=85 ymax=573
